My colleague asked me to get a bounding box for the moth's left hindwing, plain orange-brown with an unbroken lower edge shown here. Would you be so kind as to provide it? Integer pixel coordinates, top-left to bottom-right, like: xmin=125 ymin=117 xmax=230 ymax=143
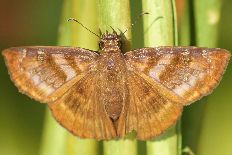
xmin=49 ymin=73 xmax=116 ymax=140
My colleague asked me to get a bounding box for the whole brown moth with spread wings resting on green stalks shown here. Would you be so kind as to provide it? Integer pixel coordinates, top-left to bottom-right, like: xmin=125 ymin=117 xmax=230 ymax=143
xmin=3 ymin=31 xmax=230 ymax=140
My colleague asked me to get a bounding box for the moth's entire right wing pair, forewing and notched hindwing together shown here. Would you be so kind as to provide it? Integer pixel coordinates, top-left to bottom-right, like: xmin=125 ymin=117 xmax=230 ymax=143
xmin=117 ymin=47 xmax=230 ymax=140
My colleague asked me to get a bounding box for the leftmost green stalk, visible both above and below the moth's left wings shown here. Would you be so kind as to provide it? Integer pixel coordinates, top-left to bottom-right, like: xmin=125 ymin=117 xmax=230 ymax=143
xmin=40 ymin=0 xmax=71 ymax=155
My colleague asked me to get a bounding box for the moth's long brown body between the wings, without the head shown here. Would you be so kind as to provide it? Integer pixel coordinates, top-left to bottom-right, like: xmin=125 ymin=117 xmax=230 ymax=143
xmin=98 ymin=51 xmax=127 ymax=120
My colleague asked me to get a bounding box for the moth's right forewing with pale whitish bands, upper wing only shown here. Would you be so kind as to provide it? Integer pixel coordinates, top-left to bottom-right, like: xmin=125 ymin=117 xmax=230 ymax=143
xmin=125 ymin=47 xmax=230 ymax=105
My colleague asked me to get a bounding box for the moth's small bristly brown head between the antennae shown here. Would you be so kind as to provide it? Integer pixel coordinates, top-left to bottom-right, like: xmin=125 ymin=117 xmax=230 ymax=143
xmin=99 ymin=31 xmax=121 ymax=49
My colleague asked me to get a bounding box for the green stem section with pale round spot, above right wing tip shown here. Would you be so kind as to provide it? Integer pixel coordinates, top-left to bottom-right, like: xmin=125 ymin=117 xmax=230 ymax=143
xmin=194 ymin=0 xmax=222 ymax=47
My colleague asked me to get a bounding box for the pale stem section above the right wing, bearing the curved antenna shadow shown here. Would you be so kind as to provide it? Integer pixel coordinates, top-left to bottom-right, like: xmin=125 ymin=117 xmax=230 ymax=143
xmin=143 ymin=0 xmax=175 ymax=46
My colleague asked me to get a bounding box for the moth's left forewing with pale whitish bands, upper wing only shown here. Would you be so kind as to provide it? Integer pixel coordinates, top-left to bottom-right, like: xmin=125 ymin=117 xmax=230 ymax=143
xmin=3 ymin=46 xmax=98 ymax=103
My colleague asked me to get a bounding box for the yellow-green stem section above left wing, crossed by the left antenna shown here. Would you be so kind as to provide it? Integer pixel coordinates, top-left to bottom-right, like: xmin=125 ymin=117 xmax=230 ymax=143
xmin=71 ymin=0 xmax=99 ymax=50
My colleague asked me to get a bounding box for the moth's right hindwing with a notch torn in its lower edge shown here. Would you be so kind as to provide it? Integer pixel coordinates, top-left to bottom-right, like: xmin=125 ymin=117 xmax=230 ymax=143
xmin=117 ymin=72 xmax=183 ymax=140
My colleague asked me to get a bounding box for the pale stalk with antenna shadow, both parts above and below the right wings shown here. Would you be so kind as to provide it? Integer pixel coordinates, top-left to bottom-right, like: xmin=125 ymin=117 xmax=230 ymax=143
xmin=143 ymin=0 xmax=181 ymax=155
